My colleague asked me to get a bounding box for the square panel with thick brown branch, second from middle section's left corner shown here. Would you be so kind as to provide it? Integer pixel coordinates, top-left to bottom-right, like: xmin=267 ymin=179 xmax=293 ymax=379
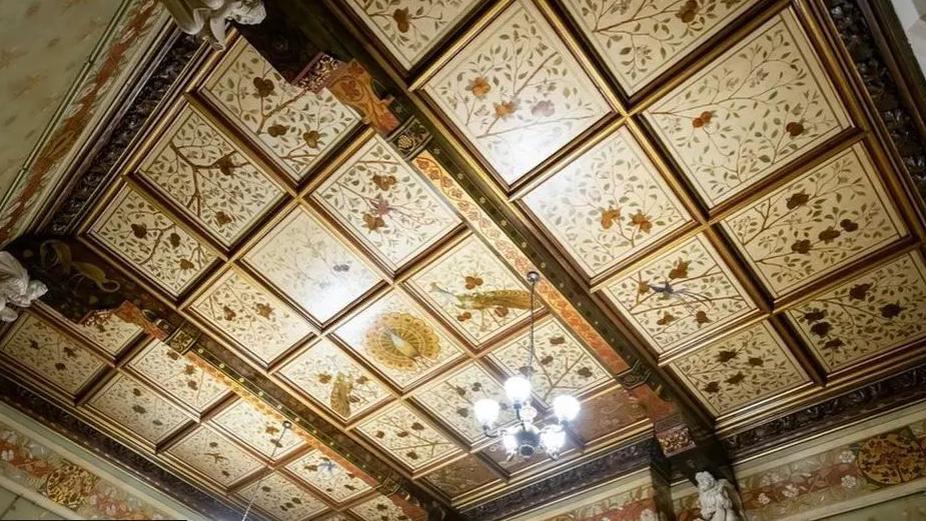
xmin=139 ymin=108 xmax=283 ymax=246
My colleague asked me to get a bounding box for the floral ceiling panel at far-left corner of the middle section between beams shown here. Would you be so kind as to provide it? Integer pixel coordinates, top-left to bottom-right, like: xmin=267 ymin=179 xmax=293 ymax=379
xmin=90 ymin=187 xmax=216 ymax=297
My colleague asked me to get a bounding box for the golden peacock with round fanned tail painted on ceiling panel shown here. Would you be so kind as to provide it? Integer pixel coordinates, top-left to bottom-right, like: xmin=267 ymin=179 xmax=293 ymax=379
xmin=366 ymin=313 xmax=440 ymax=372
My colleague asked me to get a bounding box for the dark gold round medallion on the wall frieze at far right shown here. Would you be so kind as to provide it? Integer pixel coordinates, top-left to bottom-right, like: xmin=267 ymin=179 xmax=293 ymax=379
xmin=858 ymin=430 xmax=926 ymax=485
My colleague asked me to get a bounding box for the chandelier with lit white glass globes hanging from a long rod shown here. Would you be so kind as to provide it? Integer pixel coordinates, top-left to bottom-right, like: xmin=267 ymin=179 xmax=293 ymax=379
xmin=473 ymin=271 xmax=581 ymax=460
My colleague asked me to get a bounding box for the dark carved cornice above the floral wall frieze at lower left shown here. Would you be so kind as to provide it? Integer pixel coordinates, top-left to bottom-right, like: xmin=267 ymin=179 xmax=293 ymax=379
xmin=0 ymin=374 xmax=242 ymax=519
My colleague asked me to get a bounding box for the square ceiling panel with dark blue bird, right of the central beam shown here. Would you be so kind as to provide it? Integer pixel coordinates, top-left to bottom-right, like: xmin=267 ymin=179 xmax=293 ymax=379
xmin=604 ymin=235 xmax=756 ymax=353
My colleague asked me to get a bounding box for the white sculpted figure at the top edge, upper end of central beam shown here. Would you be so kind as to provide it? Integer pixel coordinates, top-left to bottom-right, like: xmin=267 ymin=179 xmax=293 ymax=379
xmin=161 ymin=0 xmax=267 ymax=50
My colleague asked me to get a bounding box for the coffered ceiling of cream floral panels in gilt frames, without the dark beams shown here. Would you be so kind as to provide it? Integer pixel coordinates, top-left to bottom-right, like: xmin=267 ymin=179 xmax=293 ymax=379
xmin=0 ymin=0 xmax=926 ymax=521
